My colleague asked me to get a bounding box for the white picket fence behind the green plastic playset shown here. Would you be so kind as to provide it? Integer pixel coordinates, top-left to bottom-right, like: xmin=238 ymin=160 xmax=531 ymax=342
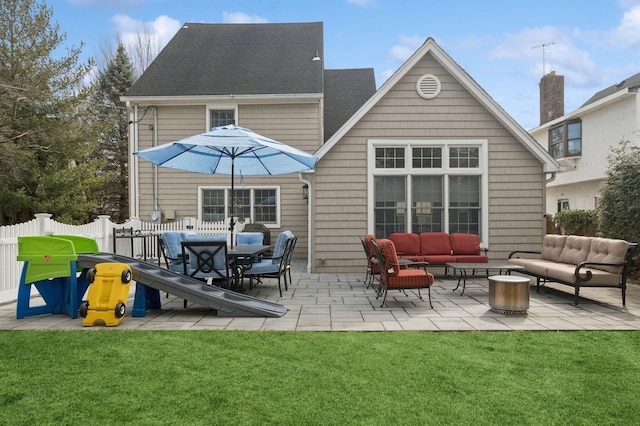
xmin=0 ymin=213 xmax=249 ymax=303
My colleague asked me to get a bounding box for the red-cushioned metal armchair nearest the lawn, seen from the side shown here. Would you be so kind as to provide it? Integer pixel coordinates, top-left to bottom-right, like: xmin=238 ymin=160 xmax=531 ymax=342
xmin=373 ymin=239 xmax=434 ymax=309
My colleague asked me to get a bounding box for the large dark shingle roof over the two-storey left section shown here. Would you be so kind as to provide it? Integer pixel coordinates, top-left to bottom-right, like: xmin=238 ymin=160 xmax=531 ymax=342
xmin=127 ymin=22 xmax=323 ymax=96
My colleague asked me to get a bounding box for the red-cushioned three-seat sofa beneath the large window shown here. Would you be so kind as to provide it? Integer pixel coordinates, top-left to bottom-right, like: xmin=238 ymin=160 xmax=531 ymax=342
xmin=389 ymin=232 xmax=489 ymax=266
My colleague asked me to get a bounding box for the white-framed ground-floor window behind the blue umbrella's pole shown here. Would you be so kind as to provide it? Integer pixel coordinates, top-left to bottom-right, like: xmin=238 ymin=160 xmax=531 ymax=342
xmin=198 ymin=186 xmax=280 ymax=227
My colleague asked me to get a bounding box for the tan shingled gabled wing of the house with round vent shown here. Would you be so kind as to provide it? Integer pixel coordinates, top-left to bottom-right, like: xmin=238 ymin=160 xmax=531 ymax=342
xmin=311 ymin=39 xmax=559 ymax=272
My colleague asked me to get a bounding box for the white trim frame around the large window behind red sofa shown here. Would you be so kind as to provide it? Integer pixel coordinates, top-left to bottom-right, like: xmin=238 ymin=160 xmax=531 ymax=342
xmin=367 ymin=139 xmax=489 ymax=241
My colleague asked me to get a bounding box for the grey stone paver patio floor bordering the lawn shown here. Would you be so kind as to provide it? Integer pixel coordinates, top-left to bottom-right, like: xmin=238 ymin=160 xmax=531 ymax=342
xmin=0 ymin=259 xmax=640 ymax=331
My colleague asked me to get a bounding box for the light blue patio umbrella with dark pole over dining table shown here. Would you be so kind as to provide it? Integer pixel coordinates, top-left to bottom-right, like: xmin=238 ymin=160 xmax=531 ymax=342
xmin=133 ymin=125 xmax=318 ymax=246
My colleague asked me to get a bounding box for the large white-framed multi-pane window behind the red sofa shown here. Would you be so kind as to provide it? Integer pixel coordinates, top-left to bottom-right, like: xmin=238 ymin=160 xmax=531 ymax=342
xmin=368 ymin=139 xmax=489 ymax=239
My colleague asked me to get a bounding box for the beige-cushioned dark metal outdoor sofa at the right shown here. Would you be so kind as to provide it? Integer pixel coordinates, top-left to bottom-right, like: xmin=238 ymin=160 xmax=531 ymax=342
xmin=509 ymin=234 xmax=638 ymax=305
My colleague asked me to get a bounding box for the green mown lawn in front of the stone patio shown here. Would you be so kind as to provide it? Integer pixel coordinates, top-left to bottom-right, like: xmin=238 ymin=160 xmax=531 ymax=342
xmin=0 ymin=329 xmax=640 ymax=425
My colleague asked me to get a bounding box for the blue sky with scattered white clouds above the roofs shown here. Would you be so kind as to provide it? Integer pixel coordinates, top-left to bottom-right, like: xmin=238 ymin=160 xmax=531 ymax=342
xmin=50 ymin=0 xmax=640 ymax=130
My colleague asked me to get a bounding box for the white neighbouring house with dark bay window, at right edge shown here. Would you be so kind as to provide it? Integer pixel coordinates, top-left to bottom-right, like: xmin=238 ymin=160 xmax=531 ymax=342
xmin=530 ymin=74 xmax=640 ymax=214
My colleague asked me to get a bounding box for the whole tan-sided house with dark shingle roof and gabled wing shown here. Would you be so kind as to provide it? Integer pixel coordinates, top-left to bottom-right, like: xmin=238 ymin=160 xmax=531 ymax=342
xmin=123 ymin=23 xmax=561 ymax=272
